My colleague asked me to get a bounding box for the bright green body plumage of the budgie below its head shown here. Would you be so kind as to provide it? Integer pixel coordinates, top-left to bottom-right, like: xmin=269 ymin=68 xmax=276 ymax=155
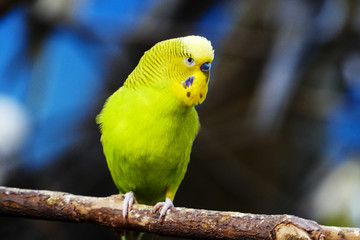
xmin=100 ymin=87 xmax=199 ymax=204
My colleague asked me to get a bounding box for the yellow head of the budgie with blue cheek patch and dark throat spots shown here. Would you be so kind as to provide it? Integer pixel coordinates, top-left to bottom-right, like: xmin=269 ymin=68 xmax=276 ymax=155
xmin=124 ymin=36 xmax=214 ymax=106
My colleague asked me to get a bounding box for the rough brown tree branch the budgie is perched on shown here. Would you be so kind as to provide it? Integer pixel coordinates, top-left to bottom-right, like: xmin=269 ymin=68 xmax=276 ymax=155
xmin=0 ymin=187 xmax=360 ymax=240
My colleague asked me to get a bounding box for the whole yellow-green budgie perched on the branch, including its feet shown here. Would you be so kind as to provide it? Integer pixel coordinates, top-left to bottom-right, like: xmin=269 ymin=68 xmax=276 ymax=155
xmin=97 ymin=36 xmax=214 ymax=231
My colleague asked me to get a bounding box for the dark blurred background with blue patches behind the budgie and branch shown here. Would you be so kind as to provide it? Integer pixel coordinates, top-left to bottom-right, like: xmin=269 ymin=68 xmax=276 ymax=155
xmin=0 ymin=0 xmax=360 ymax=240
